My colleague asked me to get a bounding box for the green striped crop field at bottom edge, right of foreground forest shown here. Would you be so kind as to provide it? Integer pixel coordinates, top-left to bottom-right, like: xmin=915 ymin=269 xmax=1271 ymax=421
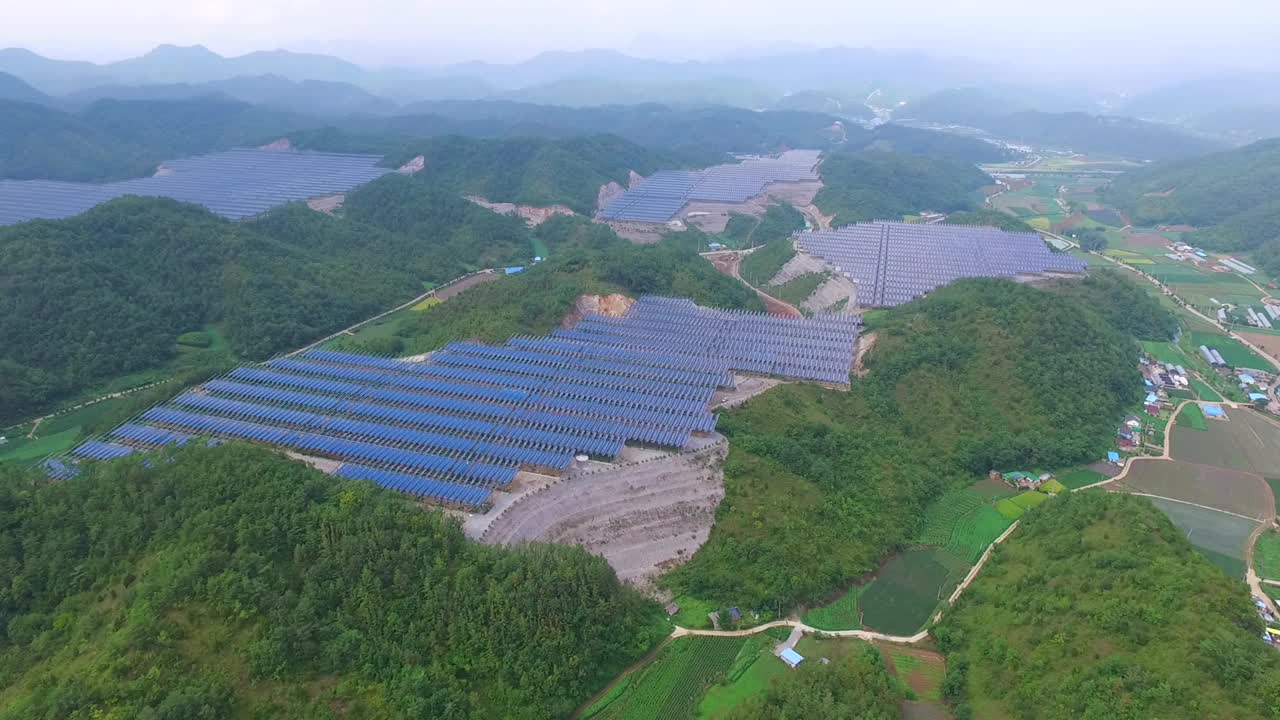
xmin=591 ymin=635 xmax=746 ymax=720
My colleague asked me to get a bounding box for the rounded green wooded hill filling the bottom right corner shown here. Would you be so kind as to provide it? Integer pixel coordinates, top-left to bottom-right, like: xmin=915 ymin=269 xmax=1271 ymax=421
xmin=934 ymin=492 xmax=1280 ymax=720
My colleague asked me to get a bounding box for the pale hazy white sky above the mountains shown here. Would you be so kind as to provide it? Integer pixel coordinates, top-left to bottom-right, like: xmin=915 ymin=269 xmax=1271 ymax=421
xmin=10 ymin=0 xmax=1280 ymax=69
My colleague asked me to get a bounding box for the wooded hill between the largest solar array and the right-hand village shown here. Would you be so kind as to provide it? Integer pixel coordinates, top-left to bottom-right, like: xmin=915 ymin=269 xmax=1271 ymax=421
xmin=668 ymin=279 xmax=1165 ymax=609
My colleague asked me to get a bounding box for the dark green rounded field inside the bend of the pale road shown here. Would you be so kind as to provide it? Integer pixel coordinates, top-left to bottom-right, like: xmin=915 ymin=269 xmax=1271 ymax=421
xmin=859 ymin=550 xmax=952 ymax=635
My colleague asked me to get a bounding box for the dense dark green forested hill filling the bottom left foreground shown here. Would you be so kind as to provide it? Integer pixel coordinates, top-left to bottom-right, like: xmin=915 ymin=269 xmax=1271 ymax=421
xmin=0 ymin=443 xmax=667 ymax=720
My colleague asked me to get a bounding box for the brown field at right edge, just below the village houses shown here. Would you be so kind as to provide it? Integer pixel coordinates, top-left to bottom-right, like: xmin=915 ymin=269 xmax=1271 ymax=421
xmin=1171 ymin=410 xmax=1280 ymax=478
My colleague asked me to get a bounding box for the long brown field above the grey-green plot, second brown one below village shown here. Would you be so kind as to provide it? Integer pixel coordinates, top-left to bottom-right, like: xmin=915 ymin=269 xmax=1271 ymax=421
xmin=1119 ymin=460 xmax=1275 ymax=520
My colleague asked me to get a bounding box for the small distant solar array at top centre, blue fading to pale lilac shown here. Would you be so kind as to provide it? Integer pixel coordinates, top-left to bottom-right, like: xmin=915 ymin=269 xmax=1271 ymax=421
xmin=600 ymin=150 xmax=819 ymax=223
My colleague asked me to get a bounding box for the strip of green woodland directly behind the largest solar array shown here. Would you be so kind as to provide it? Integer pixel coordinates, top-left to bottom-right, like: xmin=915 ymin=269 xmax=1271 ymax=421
xmin=344 ymin=215 xmax=764 ymax=354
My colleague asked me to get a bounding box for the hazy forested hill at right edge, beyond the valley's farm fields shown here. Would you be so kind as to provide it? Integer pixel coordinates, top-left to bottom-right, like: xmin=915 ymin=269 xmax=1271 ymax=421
xmin=1108 ymin=138 xmax=1280 ymax=274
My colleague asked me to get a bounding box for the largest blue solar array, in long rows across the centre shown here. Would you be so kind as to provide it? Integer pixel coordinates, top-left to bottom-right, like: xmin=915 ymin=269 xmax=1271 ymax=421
xmin=62 ymin=297 xmax=859 ymax=507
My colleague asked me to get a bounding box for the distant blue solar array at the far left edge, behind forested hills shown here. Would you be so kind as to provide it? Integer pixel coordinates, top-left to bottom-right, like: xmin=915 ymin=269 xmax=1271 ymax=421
xmin=0 ymin=150 xmax=390 ymax=225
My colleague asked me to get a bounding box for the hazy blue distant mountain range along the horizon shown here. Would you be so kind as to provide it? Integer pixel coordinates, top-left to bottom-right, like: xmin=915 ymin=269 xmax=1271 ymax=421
xmin=0 ymin=45 xmax=986 ymax=117
